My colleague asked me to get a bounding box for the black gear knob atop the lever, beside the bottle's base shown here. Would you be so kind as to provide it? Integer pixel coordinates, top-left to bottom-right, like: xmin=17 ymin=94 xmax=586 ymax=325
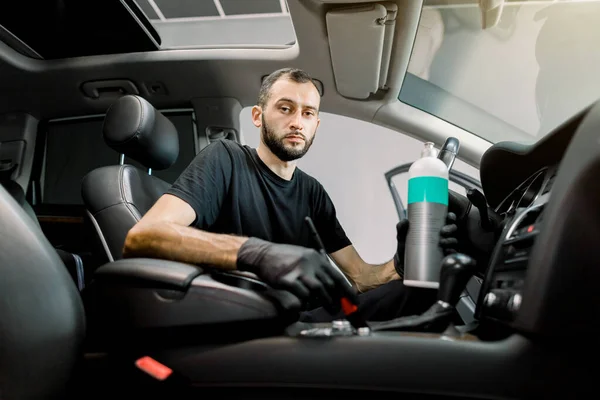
xmin=438 ymin=253 xmax=477 ymax=307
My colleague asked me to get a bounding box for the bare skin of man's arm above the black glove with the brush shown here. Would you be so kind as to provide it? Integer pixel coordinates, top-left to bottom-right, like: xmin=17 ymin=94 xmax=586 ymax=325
xmin=123 ymin=194 xmax=248 ymax=270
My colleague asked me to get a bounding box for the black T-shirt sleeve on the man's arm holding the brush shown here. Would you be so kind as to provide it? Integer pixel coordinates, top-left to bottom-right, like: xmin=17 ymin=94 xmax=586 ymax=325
xmin=167 ymin=141 xmax=233 ymax=229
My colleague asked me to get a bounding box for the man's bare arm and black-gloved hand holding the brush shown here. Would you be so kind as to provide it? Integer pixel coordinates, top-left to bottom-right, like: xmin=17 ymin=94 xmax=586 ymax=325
xmin=123 ymin=194 xmax=358 ymax=312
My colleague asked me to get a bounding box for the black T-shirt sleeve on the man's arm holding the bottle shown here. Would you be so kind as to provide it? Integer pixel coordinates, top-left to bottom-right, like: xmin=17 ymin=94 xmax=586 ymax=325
xmin=314 ymin=185 xmax=352 ymax=254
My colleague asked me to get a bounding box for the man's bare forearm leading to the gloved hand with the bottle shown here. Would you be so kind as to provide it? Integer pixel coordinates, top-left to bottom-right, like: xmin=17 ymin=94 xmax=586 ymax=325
xmin=330 ymin=245 xmax=400 ymax=292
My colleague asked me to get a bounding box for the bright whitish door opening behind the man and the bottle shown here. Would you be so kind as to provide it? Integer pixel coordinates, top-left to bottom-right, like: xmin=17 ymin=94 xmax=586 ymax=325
xmin=240 ymin=108 xmax=479 ymax=263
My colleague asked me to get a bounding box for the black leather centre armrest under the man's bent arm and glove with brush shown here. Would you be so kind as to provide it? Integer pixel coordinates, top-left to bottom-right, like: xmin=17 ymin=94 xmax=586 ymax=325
xmin=84 ymin=258 xmax=298 ymax=346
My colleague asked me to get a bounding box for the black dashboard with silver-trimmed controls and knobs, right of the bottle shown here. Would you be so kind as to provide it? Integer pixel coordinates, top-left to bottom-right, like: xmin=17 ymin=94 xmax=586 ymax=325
xmin=468 ymin=104 xmax=588 ymax=328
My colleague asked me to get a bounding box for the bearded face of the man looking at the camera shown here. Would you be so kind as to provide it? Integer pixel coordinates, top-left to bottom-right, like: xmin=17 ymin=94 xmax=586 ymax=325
xmin=255 ymin=78 xmax=321 ymax=162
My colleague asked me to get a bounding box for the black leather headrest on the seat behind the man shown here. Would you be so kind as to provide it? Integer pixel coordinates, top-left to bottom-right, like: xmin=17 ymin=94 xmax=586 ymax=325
xmin=102 ymin=95 xmax=179 ymax=170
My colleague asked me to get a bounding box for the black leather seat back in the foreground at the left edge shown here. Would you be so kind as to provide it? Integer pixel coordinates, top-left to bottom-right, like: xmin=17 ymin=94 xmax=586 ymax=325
xmin=0 ymin=185 xmax=85 ymax=400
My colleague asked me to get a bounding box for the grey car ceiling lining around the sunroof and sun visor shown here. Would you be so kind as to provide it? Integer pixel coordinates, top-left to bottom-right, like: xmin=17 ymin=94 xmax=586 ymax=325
xmin=0 ymin=0 xmax=490 ymax=164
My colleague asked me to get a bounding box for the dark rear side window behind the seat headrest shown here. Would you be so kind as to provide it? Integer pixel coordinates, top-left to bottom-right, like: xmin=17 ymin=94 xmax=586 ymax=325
xmin=40 ymin=112 xmax=196 ymax=205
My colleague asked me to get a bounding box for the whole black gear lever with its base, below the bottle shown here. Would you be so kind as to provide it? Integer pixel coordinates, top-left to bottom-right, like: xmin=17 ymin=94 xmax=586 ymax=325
xmin=369 ymin=253 xmax=476 ymax=333
